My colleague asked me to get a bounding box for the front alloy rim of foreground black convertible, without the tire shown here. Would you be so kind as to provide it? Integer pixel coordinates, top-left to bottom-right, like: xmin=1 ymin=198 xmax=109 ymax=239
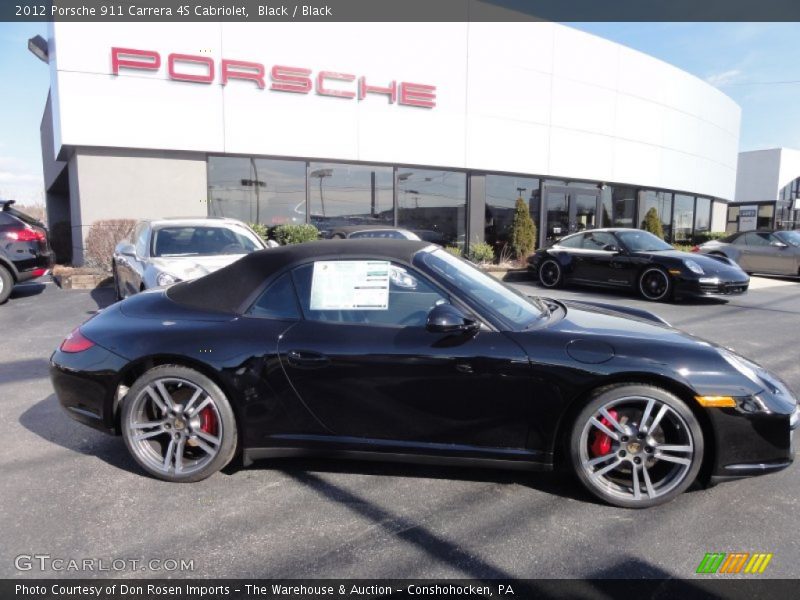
xmin=579 ymin=396 xmax=702 ymax=506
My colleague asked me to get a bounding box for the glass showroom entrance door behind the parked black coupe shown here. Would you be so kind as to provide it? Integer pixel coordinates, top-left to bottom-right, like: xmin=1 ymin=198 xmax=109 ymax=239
xmin=542 ymin=186 xmax=600 ymax=246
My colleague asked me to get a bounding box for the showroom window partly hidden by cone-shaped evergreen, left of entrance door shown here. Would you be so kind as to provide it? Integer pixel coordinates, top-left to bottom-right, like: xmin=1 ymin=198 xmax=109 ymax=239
xmin=485 ymin=175 xmax=539 ymax=254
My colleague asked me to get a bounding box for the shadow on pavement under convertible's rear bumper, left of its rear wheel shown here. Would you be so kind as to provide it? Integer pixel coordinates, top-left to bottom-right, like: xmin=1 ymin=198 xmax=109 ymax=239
xmin=19 ymin=394 xmax=141 ymax=474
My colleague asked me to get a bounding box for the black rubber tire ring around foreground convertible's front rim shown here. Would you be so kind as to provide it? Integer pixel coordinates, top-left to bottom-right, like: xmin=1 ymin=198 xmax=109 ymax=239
xmin=568 ymin=384 xmax=705 ymax=508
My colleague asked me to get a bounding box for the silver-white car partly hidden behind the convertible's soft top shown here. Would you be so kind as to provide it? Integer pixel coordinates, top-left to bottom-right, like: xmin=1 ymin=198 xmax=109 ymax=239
xmin=111 ymin=217 xmax=267 ymax=300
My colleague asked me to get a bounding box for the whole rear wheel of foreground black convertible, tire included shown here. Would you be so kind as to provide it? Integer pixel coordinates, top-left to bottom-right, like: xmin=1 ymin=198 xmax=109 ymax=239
xmin=120 ymin=365 xmax=238 ymax=483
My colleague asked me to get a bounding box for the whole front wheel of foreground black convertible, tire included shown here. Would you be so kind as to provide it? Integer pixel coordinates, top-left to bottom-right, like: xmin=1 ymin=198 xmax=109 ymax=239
xmin=569 ymin=384 xmax=704 ymax=508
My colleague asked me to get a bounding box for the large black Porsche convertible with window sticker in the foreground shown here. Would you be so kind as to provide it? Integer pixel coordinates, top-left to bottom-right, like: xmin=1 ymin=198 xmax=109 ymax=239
xmin=51 ymin=240 xmax=798 ymax=507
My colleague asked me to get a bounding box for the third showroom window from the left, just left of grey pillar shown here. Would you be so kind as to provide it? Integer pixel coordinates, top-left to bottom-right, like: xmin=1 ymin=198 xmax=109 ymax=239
xmin=397 ymin=168 xmax=467 ymax=248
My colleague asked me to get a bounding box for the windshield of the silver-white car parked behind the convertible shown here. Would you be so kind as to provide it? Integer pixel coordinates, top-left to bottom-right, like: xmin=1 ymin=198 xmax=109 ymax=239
xmin=151 ymin=225 xmax=264 ymax=257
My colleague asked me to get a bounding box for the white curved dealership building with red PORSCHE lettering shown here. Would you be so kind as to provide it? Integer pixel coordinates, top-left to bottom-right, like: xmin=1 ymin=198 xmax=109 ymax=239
xmin=41 ymin=22 xmax=740 ymax=263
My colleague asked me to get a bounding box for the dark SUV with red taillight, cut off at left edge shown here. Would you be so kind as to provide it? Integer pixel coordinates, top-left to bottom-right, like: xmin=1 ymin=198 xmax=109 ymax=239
xmin=0 ymin=200 xmax=53 ymax=304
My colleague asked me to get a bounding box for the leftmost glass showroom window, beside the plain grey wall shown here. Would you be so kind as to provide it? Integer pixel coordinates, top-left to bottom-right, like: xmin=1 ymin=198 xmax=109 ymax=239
xmin=208 ymin=156 xmax=306 ymax=226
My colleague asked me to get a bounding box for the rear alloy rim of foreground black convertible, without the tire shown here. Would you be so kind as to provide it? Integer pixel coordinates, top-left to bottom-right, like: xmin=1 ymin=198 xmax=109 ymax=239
xmin=124 ymin=377 xmax=224 ymax=477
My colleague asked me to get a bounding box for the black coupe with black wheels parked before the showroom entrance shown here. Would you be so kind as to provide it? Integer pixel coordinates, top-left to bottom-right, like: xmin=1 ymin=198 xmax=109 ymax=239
xmin=528 ymin=228 xmax=750 ymax=302
